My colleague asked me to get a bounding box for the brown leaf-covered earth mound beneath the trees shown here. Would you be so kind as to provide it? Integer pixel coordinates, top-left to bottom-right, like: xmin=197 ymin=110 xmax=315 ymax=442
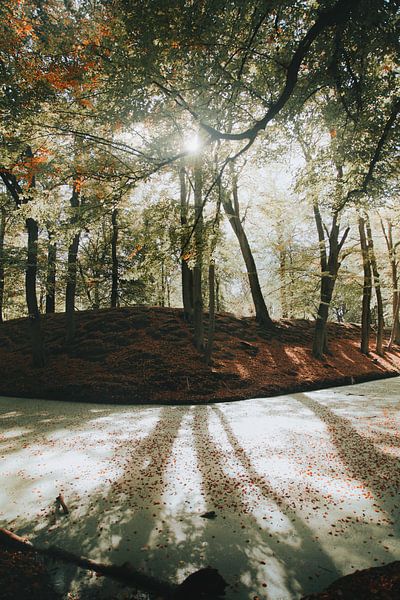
xmin=0 ymin=306 xmax=400 ymax=404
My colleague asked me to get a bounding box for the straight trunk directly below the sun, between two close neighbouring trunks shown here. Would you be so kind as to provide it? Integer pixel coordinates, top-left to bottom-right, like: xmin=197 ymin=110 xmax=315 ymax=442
xmin=193 ymin=156 xmax=204 ymax=351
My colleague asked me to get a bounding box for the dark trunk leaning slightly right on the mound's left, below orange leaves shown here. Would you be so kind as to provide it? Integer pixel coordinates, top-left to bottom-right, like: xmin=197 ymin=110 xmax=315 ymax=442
xmin=65 ymin=181 xmax=80 ymax=344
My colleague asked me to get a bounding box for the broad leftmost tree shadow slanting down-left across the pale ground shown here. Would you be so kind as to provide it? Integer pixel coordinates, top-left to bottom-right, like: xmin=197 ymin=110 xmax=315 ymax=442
xmin=4 ymin=407 xmax=183 ymax=598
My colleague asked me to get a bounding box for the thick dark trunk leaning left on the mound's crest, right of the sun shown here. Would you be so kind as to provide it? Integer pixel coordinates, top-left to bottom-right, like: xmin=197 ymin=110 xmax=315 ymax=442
xmin=222 ymin=175 xmax=274 ymax=329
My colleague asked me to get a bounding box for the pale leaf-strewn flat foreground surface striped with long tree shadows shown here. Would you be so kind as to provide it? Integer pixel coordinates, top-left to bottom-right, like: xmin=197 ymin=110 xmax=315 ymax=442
xmin=0 ymin=378 xmax=400 ymax=600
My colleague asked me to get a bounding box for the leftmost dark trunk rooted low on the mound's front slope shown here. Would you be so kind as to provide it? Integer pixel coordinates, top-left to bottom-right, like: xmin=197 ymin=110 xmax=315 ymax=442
xmin=25 ymin=218 xmax=46 ymax=367
